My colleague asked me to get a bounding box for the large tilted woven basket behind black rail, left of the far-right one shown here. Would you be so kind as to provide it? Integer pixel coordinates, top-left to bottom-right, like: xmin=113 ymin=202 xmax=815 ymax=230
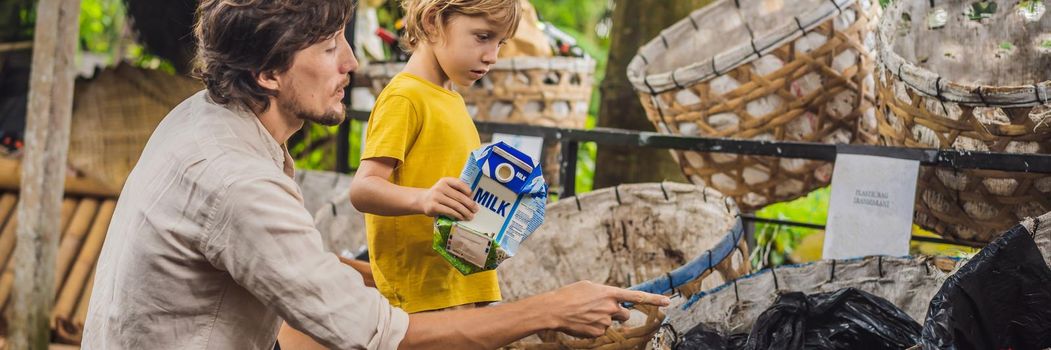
xmin=627 ymin=0 xmax=880 ymax=210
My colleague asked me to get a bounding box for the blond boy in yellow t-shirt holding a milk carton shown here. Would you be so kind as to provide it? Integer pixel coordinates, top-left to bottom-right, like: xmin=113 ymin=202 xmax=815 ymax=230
xmin=351 ymin=0 xmax=520 ymax=313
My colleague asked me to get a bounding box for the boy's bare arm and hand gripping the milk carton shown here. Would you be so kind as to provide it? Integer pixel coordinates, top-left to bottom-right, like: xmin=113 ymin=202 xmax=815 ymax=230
xmin=350 ymin=158 xmax=478 ymax=221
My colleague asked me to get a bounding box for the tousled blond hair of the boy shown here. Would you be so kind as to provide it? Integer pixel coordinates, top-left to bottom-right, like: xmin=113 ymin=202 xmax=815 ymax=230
xmin=401 ymin=0 xmax=521 ymax=53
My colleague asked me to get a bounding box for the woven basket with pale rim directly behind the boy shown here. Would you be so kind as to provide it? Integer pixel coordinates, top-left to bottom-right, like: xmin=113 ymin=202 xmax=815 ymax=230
xmin=359 ymin=57 xmax=595 ymax=192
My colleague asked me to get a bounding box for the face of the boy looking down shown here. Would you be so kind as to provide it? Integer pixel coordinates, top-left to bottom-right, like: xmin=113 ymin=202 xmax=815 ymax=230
xmin=434 ymin=16 xmax=511 ymax=86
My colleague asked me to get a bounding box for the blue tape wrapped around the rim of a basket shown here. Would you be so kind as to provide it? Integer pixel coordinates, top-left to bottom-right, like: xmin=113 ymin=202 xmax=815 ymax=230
xmin=628 ymin=217 xmax=744 ymax=294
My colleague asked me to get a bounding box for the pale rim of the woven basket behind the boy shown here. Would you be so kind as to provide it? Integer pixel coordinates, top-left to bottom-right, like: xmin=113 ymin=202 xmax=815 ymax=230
xmin=360 ymin=56 xmax=595 ymax=78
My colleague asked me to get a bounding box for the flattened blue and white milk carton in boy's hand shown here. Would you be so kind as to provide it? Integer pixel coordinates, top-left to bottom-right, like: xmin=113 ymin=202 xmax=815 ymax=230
xmin=434 ymin=142 xmax=548 ymax=274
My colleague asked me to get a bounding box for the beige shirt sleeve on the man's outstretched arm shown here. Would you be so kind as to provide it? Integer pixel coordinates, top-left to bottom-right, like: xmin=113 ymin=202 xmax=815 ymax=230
xmin=202 ymin=178 xmax=409 ymax=349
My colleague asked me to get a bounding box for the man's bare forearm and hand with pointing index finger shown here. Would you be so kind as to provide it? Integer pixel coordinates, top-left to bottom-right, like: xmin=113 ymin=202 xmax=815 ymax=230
xmin=398 ymin=282 xmax=668 ymax=349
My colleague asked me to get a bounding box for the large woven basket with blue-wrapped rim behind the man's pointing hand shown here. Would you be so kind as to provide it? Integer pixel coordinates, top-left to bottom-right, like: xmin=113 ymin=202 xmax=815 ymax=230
xmin=499 ymin=183 xmax=748 ymax=349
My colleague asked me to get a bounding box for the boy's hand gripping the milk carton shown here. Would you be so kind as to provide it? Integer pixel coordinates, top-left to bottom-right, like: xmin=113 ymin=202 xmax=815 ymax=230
xmin=416 ymin=178 xmax=478 ymax=221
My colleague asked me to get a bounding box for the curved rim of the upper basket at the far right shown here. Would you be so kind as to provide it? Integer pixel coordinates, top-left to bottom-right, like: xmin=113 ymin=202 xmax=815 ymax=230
xmin=875 ymin=1 xmax=1051 ymax=107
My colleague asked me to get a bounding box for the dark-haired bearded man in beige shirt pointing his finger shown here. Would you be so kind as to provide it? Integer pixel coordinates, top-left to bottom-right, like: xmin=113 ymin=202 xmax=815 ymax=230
xmin=82 ymin=0 xmax=667 ymax=349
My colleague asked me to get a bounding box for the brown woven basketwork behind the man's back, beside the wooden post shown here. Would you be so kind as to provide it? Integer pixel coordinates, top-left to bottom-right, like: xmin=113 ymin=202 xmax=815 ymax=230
xmin=69 ymin=63 xmax=204 ymax=190
